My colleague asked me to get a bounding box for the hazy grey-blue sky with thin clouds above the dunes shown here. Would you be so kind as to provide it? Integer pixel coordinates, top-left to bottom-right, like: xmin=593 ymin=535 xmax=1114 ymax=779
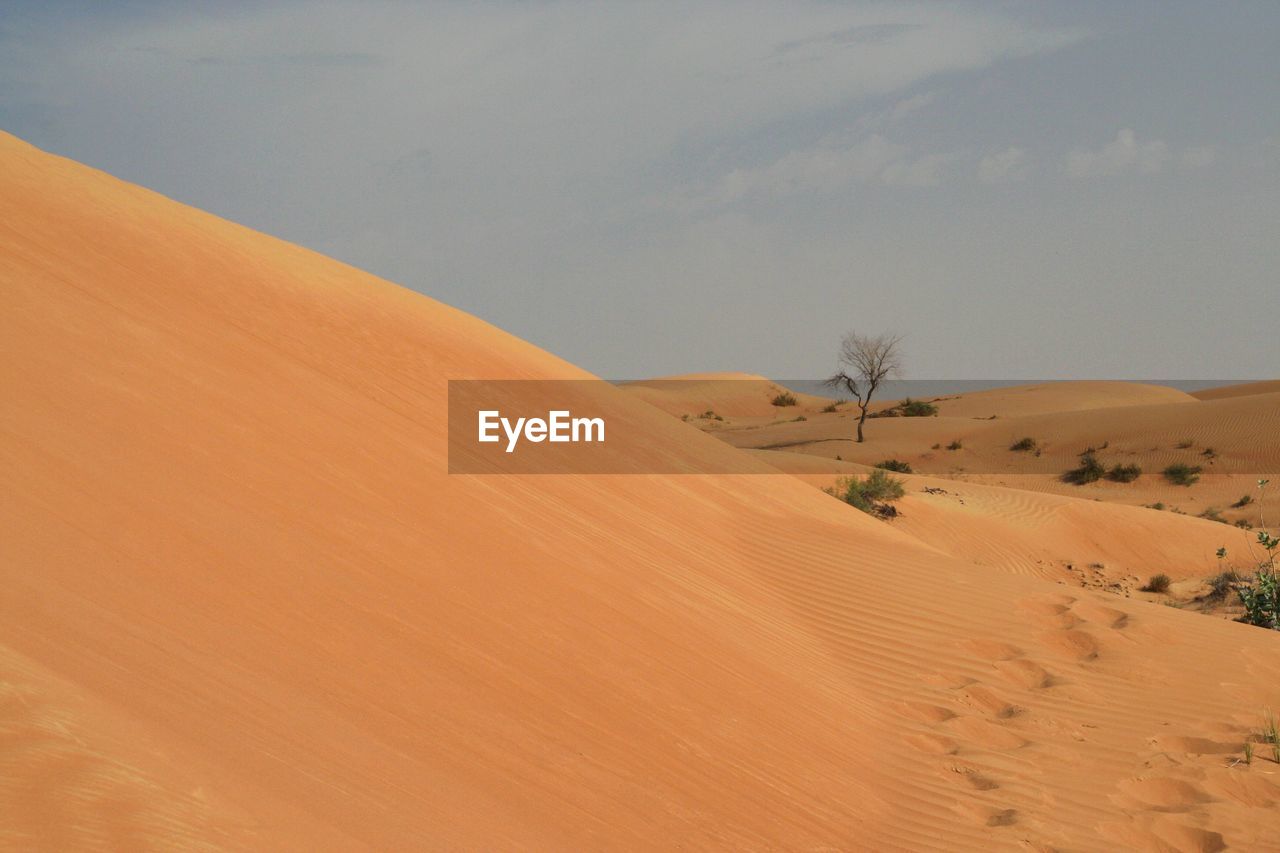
xmin=0 ymin=0 xmax=1280 ymax=379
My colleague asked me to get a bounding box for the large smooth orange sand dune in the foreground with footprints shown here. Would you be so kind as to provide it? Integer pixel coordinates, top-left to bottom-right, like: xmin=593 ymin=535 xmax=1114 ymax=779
xmin=0 ymin=129 xmax=1280 ymax=850
